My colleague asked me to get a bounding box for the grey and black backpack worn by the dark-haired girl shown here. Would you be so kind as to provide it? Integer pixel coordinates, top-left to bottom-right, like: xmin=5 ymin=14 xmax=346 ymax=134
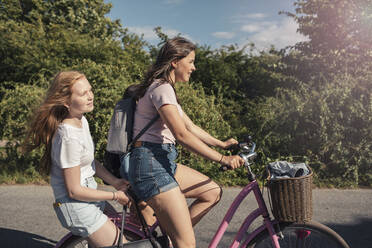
xmin=103 ymin=85 xmax=160 ymax=178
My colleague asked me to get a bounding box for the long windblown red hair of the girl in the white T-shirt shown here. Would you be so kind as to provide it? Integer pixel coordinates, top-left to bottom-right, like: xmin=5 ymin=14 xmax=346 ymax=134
xmin=23 ymin=71 xmax=85 ymax=173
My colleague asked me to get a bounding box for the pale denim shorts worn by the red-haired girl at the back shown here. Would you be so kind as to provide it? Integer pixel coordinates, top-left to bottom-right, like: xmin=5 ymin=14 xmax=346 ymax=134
xmin=53 ymin=177 xmax=107 ymax=237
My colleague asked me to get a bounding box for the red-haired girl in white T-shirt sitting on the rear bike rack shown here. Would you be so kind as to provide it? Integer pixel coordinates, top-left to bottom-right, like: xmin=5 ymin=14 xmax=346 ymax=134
xmin=24 ymin=71 xmax=129 ymax=247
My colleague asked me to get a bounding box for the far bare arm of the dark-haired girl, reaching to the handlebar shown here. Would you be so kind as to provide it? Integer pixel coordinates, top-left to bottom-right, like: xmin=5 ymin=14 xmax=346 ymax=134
xmin=183 ymin=113 xmax=238 ymax=149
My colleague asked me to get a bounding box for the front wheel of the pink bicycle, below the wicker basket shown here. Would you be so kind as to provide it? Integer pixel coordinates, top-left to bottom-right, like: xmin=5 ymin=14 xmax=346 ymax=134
xmin=248 ymin=222 xmax=349 ymax=248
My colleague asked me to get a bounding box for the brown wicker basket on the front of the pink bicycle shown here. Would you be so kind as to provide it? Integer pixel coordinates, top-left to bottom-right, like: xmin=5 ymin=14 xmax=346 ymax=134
xmin=268 ymin=168 xmax=313 ymax=222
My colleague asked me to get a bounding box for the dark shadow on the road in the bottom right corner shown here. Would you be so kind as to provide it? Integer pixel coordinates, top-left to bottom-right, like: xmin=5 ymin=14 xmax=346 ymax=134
xmin=323 ymin=218 xmax=372 ymax=248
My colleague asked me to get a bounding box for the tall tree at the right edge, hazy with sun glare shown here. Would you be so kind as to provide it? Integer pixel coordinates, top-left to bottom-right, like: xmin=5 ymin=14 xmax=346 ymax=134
xmin=274 ymin=0 xmax=372 ymax=185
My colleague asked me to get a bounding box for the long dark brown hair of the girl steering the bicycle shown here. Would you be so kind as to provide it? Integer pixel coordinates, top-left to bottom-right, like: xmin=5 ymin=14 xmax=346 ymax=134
xmin=135 ymin=36 xmax=196 ymax=98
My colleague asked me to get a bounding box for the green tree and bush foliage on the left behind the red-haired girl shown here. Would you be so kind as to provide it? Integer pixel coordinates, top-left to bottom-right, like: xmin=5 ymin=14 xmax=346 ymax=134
xmin=0 ymin=0 xmax=149 ymax=180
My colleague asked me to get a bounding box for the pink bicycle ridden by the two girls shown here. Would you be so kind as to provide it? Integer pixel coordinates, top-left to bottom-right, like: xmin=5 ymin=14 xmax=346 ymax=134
xmin=56 ymin=140 xmax=349 ymax=248
